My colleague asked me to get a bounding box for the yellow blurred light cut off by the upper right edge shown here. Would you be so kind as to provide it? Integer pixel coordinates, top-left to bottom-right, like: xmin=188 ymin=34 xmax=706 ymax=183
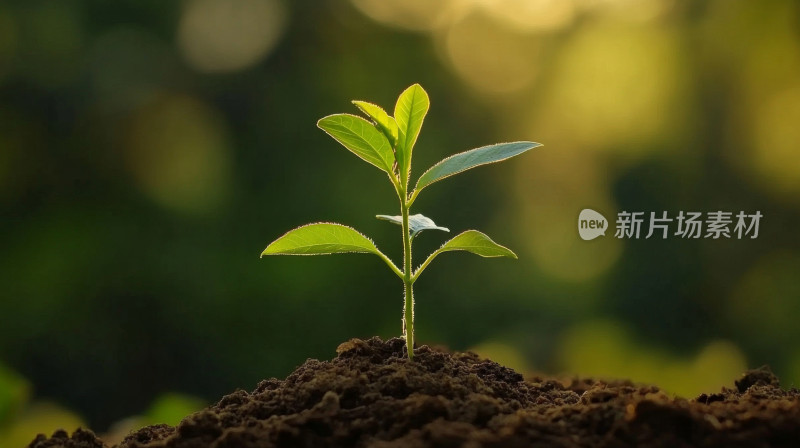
xmin=702 ymin=1 xmax=800 ymax=206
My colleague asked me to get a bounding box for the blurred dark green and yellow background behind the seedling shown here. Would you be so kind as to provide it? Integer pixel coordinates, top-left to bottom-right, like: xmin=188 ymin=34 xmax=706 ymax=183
xmin=0 ymin=0 xmax=800 ymax=446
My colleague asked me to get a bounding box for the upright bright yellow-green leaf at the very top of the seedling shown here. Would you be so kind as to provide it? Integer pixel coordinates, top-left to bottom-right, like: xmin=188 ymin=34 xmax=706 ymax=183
xmin=394 ymin=84 xmax=431 ymax=186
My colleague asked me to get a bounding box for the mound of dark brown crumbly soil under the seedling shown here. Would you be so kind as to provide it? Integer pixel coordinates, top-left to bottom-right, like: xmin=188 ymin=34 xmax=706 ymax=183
xmin=29 ymin=338 xmax=800 ymax=448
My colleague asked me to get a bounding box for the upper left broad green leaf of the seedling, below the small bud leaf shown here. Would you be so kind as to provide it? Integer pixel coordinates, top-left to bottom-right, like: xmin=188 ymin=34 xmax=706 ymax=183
xmin=317 ymin=114 xmax=394 ymax=175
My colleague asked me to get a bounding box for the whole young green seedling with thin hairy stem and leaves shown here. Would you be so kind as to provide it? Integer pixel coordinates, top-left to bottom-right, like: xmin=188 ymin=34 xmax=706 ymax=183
xmin=261 ymin=84 xmax=541 ymax=360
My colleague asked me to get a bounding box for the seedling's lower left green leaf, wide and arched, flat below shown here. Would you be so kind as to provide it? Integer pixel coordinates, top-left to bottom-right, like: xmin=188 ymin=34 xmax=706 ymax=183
xmin=261 ymin=223 xmax=380 ymax=257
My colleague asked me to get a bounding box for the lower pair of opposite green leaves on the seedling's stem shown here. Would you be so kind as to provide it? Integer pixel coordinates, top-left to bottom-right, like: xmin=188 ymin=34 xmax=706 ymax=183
xmin=261 ymin=221 xmax=517 ymax=273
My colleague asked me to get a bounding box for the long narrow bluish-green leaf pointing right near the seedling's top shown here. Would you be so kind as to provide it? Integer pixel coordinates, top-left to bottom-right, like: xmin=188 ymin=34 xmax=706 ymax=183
xmin=415 ymin=142 xmax=542 ymax=192
